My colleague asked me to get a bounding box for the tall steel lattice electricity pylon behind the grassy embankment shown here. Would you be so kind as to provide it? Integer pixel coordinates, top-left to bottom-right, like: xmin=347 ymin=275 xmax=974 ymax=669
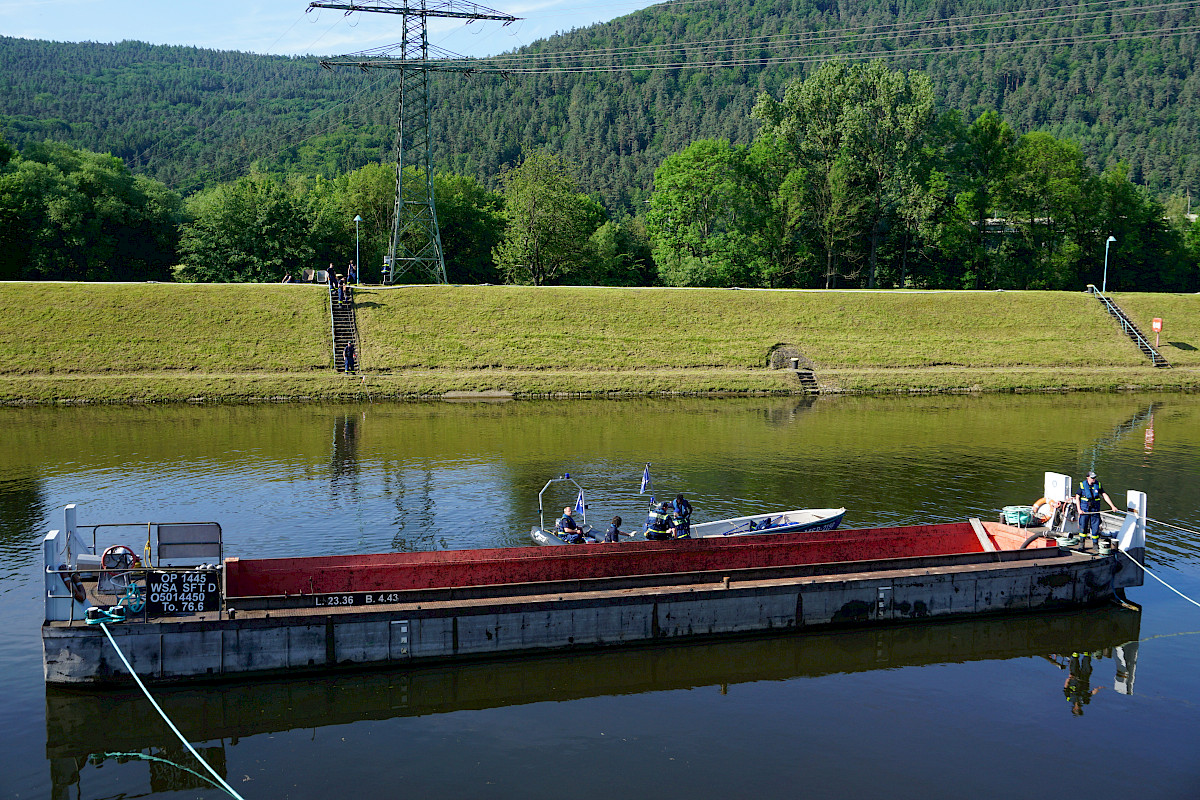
xmin=308 ymin=0 xmax=518 ymax=283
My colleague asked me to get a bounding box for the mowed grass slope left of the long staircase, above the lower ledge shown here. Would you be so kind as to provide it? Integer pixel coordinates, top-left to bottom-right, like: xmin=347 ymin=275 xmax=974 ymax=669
xmin=0 ymin=282 xmax=332 ymax=375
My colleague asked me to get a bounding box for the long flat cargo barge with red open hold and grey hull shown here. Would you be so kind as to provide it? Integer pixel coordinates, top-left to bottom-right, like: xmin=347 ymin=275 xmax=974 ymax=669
xmin=42 ymin=474 xmax=1145 ymax=684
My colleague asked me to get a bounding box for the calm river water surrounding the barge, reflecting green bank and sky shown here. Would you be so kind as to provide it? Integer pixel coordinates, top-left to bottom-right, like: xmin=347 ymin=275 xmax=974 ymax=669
xmin=0 ymin=395 xmax=1200 ymax=800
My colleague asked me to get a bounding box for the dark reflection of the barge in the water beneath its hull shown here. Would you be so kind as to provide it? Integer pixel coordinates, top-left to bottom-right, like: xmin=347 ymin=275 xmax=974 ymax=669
xmin=46 ymin=607 xmax=1141 ymax=796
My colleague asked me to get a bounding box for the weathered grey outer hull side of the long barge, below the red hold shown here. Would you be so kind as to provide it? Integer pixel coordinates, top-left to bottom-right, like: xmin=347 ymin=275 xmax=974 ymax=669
xmin=42 ymin=551 xmax=1121 ymax=685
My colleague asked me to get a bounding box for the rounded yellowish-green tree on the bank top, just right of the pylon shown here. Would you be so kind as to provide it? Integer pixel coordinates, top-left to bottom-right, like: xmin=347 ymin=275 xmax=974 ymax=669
xmin=493 ymin=150 xmax=605 ymax=285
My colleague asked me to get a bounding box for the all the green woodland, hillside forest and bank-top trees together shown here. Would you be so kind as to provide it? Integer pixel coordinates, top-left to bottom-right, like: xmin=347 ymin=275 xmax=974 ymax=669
xmin=0 ymin=0 xmax=1200 ymax=291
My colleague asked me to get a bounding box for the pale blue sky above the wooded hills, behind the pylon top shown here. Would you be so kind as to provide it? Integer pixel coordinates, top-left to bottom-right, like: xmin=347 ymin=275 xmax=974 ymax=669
xmin=0 ymin=0 xmax=654 ymax=56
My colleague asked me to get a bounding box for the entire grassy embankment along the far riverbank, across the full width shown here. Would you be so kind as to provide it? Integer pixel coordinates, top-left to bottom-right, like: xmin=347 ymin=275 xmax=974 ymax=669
xmin=0 ymin=283 xmax=1200 ymax=403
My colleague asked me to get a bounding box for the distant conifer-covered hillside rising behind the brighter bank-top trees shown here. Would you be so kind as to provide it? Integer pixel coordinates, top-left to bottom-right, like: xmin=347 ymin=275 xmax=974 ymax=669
xmin=0 ymin=0 xmax=1200 ymax=213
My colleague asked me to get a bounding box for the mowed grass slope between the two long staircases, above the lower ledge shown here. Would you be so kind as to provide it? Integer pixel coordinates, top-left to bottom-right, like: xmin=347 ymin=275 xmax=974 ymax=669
xmin=358 ymin=287 xmax=1161 ymax=371
